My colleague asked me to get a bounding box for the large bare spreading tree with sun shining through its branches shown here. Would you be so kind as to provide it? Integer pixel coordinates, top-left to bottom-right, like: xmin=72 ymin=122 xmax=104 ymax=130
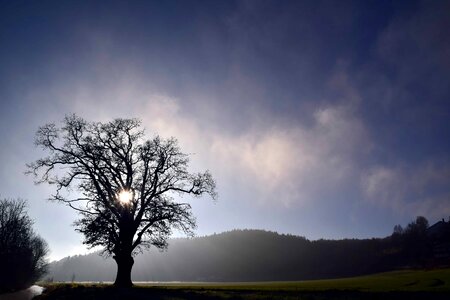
xmin=27 ymin=115 xmax=216 ymax=287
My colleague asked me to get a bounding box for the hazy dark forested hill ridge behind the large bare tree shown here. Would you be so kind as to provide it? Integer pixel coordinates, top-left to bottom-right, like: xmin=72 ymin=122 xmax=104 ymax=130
xmin=47 ymin=217 xmax=450 ymax=281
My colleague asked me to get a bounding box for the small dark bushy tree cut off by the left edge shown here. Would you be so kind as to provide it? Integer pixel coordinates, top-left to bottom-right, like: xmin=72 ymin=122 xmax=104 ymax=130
xmin=0 ymin=200 xmax=48 ymax=291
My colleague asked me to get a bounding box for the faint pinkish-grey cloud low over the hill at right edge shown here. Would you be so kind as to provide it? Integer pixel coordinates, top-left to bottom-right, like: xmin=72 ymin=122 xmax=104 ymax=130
xmin=360 ymin=161 xmax=450 ymax=218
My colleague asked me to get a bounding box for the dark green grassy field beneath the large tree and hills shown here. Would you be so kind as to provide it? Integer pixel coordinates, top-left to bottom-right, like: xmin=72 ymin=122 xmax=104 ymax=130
xmin=38 ymin=269 xmax=450 ymax=300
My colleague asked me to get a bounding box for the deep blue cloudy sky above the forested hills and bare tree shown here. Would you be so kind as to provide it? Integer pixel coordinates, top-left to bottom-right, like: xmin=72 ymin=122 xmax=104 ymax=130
xmin=0 ymin=0 xmax=450 ymax=260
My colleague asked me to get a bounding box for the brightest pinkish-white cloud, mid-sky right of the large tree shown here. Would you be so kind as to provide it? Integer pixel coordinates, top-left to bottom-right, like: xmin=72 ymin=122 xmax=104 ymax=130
xmin=211 ymin=98 xmax=370 ymax=206
